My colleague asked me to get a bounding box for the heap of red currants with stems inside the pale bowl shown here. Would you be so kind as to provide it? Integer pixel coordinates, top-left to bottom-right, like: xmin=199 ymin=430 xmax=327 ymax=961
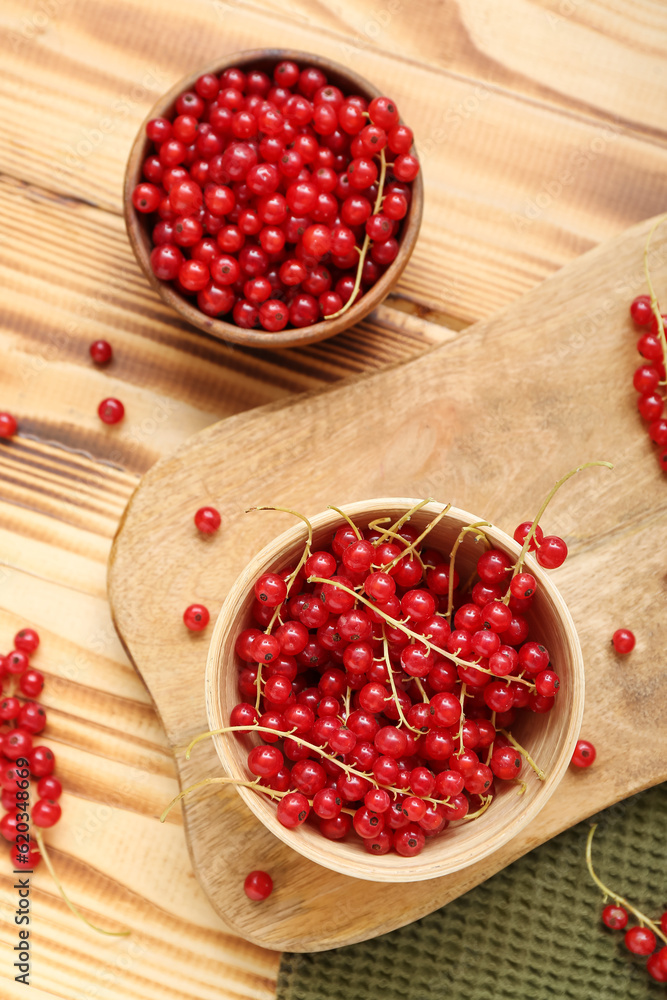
xmin=230 ymin=508 xmax=566 ymax=857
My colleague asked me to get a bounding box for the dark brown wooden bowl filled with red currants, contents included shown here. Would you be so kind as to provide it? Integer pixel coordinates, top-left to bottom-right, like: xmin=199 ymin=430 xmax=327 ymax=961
xmin=124 ymin=49 xmax=423 ymax=348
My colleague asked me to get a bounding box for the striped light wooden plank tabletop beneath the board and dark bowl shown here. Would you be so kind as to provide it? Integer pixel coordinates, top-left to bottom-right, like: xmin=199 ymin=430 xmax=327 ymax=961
xmin=0 ymin=0 xmax=667 ymax=1000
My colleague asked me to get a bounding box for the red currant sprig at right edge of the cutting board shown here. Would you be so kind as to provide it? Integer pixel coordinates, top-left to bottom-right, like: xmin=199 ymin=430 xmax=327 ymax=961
xmin=630 ymin=295 xmax=667 ymax=472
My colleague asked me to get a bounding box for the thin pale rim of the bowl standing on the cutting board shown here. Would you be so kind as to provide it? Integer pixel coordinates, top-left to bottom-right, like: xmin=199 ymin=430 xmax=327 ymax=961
xmin=205 ymin=497 xmax=585 ymax=882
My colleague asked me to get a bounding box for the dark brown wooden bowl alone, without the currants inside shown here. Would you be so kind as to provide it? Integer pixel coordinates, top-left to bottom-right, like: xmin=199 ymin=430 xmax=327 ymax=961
xmin=123 ymin=49 xmax=424 ymax=349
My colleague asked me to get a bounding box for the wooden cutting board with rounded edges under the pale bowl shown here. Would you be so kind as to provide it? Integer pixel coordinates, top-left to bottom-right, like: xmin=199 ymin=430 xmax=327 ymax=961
xmin=109 ymin=213 xmax=667 ymax=951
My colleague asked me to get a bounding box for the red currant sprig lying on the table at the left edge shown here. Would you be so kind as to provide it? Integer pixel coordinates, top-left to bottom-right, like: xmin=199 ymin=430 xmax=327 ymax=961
xmin=0 ymin=628 xmax=62 ymax=869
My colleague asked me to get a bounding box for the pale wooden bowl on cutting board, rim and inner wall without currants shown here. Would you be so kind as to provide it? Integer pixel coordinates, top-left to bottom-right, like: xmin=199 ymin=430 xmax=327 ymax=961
xmin=206 ymin=497 xmax=584 ymax=882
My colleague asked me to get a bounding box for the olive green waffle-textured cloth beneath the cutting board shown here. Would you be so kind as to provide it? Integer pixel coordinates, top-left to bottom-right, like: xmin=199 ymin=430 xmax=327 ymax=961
xmin=277 ymin=784 xmax=667 ymax=1000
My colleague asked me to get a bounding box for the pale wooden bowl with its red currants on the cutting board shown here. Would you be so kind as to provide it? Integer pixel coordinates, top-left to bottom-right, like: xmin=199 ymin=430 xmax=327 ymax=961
xmin=204 ymin=498 xmax=584 ymax=882
